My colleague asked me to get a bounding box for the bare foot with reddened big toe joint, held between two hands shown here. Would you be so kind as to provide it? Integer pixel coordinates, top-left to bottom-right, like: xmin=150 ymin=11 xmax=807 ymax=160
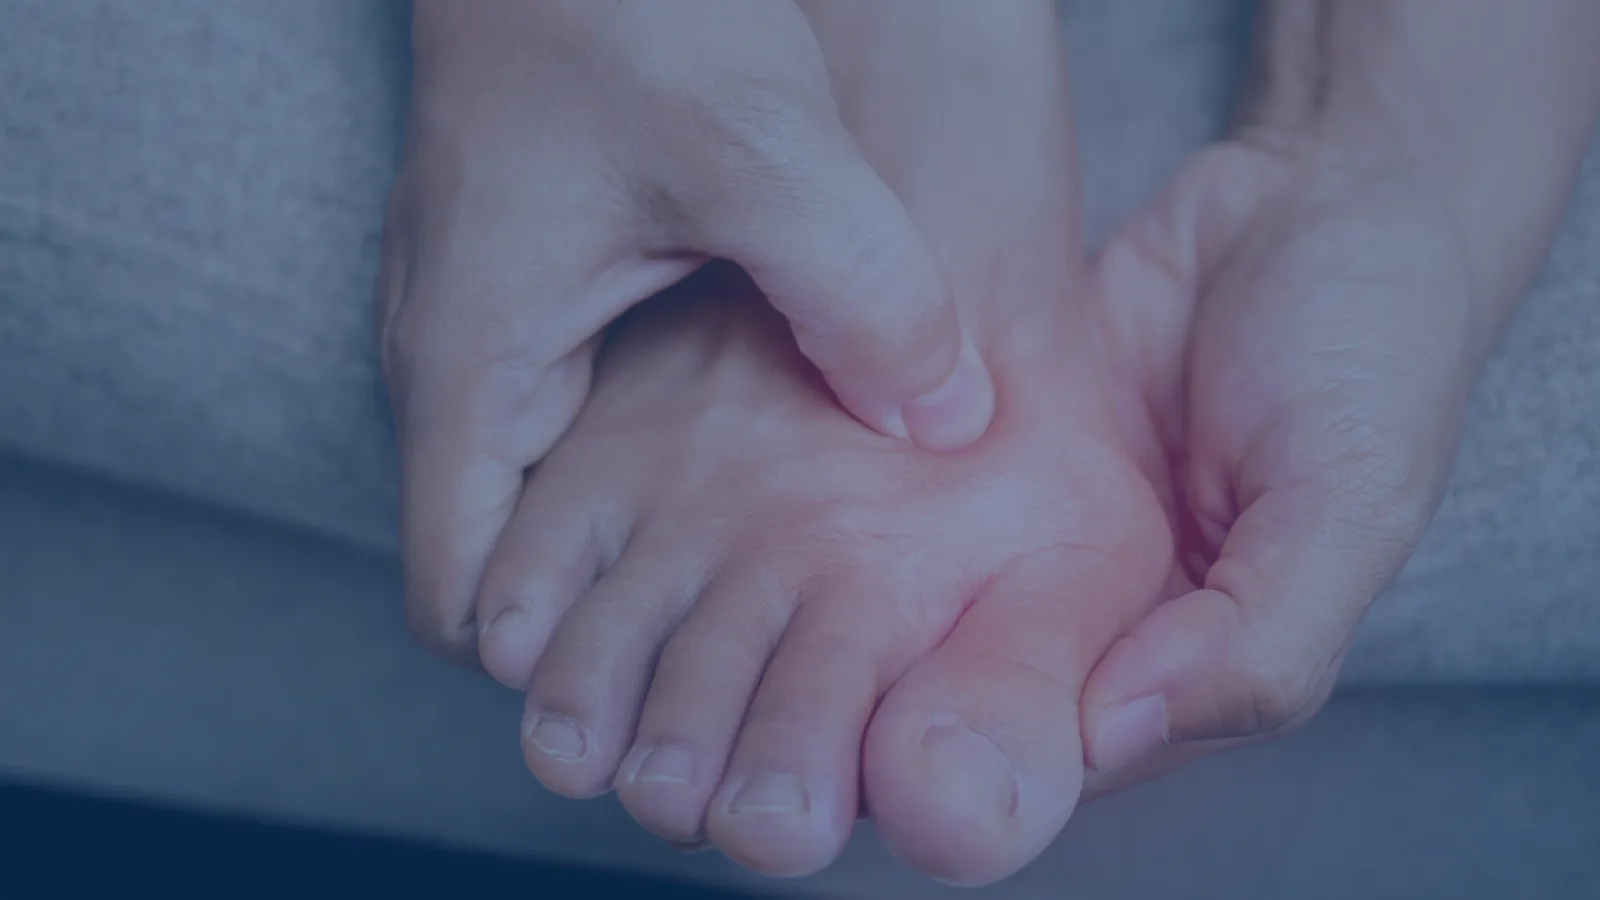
xmin=478 ymin=3 xmax=1171 ymax=882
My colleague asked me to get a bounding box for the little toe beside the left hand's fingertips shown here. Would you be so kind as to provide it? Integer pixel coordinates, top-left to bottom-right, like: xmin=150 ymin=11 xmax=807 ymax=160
xmin=477 ymin=472 xmax=626 ymax=690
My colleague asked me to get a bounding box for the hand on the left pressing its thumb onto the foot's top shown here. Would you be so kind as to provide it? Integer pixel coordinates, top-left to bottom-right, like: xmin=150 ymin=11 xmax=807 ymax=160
xmin=379 ymin=0 xmax=994 ymax=655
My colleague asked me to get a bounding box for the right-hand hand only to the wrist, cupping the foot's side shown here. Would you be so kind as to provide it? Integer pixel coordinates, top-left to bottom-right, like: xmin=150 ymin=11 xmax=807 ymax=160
xmin=1085 ymin=131 xmax=1561 ymax=791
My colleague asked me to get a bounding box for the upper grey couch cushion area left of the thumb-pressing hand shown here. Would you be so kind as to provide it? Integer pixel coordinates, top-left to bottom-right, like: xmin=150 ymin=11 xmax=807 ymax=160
xmin=0 ymin=0 xmax=406 ymax=546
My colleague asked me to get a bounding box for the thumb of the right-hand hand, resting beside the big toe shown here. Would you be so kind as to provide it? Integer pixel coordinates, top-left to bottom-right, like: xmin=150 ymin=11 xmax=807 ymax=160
xmin=1083 ymin=487 xmax=1426 ymax=775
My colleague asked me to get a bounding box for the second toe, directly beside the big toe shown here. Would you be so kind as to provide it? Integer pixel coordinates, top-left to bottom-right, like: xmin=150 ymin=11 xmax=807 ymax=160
xmin=706 ymin=594 xmax=883 ymax=876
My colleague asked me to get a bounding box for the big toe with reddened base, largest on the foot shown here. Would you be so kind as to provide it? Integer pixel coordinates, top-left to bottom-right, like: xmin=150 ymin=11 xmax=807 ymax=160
xmin=862 ymin=551 xmax=1115 ymax=884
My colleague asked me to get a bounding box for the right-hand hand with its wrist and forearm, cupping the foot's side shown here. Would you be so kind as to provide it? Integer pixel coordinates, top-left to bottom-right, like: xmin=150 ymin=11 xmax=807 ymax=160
xmin=1085 ymin=0 xmax=1600 ymax=791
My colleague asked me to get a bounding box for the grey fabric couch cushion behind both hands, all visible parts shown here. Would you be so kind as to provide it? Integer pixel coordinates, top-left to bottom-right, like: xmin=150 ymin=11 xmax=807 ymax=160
xmin=0 ymin=0 xmax=1600 ymax=682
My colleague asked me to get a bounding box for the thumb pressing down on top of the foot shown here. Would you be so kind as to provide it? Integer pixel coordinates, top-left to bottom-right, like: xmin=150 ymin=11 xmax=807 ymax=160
xmin=702 ymin=136 xmax=995 ymax=450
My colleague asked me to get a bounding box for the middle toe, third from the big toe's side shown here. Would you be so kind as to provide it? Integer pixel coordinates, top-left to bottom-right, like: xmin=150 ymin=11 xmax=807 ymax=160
xmin=616 ymin=572 xmax=795 ymax=844
